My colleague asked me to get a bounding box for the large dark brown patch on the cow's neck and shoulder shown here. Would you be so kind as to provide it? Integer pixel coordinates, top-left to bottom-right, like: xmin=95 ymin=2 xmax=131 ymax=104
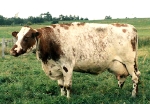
xmin=37 ymin=27 xmax=63 ymax=63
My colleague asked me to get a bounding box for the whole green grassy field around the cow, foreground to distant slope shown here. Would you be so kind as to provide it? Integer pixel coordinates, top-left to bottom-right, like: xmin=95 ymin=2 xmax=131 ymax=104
xmin=0 ymin=19 xmax=150 ymax=104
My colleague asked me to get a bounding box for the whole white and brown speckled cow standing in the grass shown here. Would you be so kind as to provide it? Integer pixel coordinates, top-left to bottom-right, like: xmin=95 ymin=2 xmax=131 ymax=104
xmin=10 ymin=22 xmax=140 ymax=98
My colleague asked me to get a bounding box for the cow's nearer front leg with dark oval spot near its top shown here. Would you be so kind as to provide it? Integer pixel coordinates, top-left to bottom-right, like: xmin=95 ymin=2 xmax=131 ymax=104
xmin=63 ymin=66 xmax=73 ymax=98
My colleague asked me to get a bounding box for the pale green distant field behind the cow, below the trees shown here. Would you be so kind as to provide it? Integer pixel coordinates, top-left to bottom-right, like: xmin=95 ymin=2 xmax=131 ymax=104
xmin=0 ymin=18 xmax=150 ymax=38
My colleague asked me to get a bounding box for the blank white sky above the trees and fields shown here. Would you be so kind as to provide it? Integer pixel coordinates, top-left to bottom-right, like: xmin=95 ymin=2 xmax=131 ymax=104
xmin=0 ymin=0 xmax=150 ymax=20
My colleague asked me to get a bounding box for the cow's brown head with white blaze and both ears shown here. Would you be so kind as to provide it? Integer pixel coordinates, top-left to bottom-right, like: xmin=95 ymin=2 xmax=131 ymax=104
xmin=10 ymin=26 xmax=39 ymax=56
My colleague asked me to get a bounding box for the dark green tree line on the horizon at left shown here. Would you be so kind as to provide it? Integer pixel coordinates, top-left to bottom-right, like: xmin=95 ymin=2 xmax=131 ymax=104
xmin=0 ymin=12 xmax=88 ymax=25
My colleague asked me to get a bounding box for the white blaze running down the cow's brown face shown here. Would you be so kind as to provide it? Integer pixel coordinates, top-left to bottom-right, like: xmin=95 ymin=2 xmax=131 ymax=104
xmin=14 ymin=27 xmax=30 ymax=53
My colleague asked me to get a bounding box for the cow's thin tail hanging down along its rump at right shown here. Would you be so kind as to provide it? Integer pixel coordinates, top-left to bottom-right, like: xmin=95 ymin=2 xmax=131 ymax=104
xmin=134 ymin=32 xmax=141 ymax=76
